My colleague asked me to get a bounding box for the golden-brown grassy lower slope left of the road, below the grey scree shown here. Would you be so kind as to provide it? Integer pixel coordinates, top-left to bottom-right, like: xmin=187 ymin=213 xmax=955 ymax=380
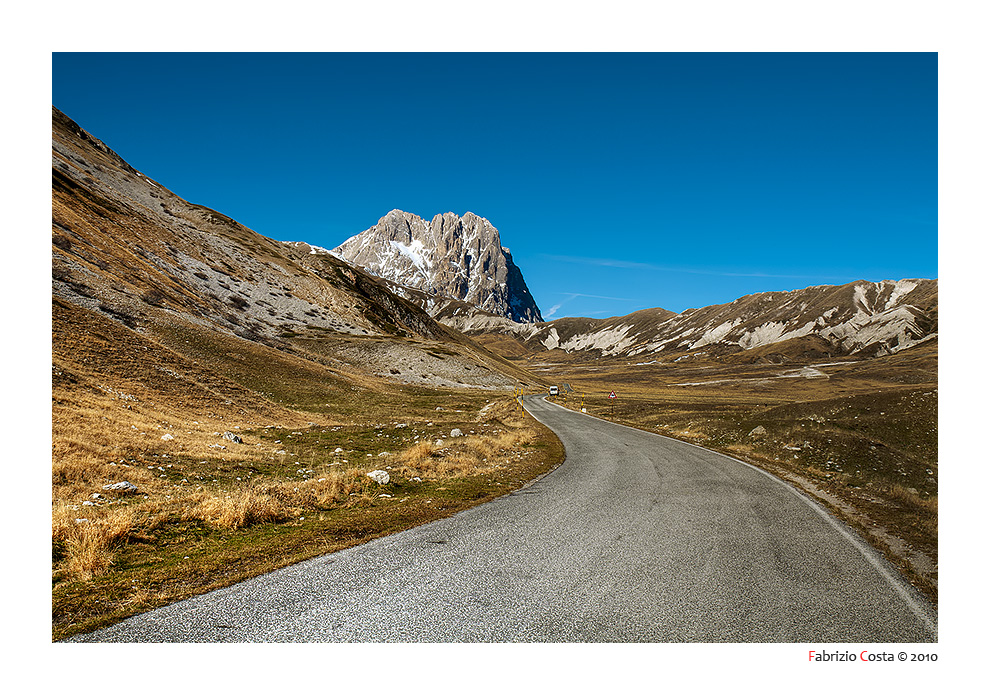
xmin=52 ymin=301 xmax=563 ymax=638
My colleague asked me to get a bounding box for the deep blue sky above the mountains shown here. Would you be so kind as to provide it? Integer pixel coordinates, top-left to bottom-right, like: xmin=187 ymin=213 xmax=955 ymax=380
xmin=52 ymin=53 xmax=938 ymax=318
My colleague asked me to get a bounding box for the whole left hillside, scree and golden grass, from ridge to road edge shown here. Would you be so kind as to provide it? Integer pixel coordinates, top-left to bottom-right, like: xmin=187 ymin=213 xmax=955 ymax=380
xmin=52 ymin=109 xmax=563 ymax=638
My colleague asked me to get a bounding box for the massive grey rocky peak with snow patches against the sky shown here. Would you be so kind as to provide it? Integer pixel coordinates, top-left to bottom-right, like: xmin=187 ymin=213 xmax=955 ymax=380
xmin=332 ymin=210 xmax=543 ymax=323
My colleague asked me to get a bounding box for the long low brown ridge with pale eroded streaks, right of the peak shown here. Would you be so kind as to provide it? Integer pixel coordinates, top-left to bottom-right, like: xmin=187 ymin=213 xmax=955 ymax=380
xmin=454 ymin=279 xmax=938 ymax=357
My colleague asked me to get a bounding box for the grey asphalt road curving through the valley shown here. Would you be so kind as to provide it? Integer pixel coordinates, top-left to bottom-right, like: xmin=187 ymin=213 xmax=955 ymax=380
xmin=72 ymin=398 xmax=936 ymax=643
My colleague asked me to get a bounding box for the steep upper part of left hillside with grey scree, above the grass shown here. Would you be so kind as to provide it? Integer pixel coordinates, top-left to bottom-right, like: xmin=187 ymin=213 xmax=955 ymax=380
xmin=52 ymin=107 xmax=536 ymax=388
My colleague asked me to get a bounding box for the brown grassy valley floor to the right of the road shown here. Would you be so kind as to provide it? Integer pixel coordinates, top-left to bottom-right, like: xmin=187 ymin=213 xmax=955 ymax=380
xmin=527 ymin=346 xmax=938 ymax=602
